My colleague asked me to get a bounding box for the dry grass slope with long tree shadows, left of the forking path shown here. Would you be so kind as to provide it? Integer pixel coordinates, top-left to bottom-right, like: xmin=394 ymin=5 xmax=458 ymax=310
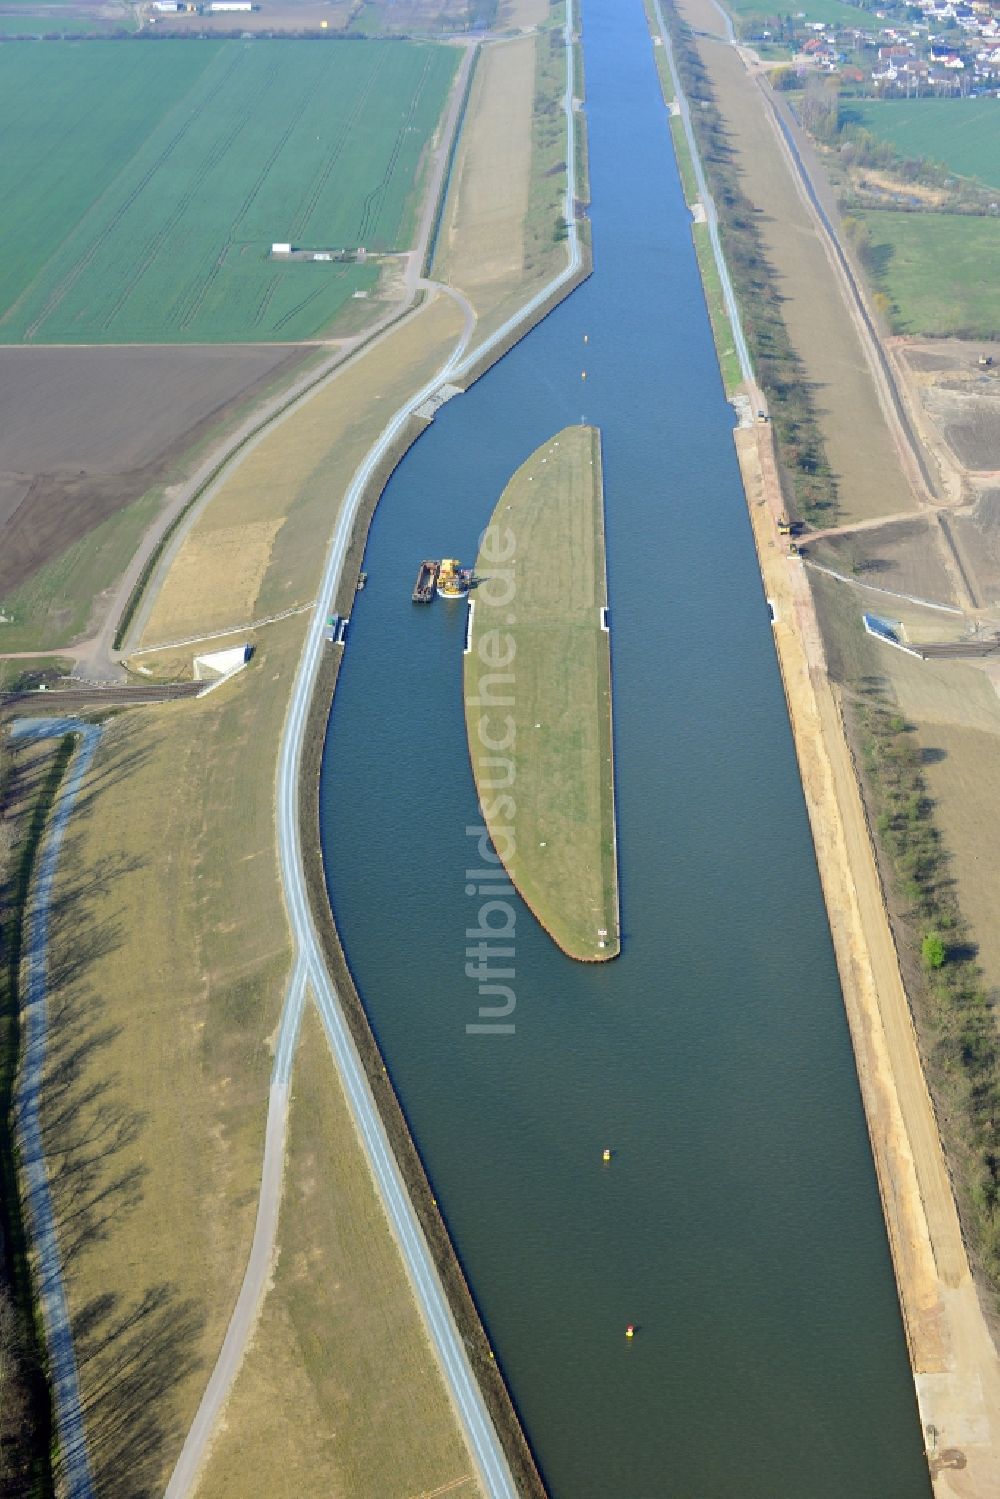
xmin=35 ymin=619 xmax=304 ymax=1496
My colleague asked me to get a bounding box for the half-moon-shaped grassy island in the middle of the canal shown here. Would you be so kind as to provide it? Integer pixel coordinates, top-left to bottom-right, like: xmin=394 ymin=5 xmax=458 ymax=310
xmin=465 ymin=426 xmax=621 ymax=962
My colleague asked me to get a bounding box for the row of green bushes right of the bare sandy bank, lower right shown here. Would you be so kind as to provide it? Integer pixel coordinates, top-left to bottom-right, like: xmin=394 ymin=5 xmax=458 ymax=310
xmin=856 ymin=702 xmax=1000 ymax=1294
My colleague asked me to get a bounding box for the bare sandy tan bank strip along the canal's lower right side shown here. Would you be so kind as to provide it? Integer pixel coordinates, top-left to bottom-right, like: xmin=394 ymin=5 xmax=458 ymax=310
xmin=650 ymin=0 xmax=1000 ymax=1499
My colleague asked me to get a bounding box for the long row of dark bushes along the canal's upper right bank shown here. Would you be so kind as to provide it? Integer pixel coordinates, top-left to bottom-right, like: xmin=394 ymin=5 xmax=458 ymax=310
xmin=666 ymin=4 xmax=838 ymax=526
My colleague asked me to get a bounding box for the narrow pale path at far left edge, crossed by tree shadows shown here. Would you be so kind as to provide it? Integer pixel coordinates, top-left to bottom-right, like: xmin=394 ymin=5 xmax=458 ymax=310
xmin=10 ymin=718 xmax=100 ymax=1499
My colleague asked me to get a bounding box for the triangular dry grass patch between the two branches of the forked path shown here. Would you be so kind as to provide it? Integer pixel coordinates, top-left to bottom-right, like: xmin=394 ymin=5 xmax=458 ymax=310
xmin=196 ymin=1006 xmax=481 ymax=1499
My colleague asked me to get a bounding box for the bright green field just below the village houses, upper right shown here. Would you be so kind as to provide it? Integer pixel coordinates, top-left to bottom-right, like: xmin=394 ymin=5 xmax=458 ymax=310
xmin=844 ymin=99 xmax=1000 ymax=189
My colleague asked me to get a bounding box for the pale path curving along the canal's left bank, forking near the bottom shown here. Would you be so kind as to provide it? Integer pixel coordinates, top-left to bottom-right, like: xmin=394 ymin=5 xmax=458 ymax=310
xmin=166 ymin=0 xmax=583 ymax=1499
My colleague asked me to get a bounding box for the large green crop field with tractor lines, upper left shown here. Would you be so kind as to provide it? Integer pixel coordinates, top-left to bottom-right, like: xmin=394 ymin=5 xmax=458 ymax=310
xmin=0 ymin=40 xmax=459 ymax=343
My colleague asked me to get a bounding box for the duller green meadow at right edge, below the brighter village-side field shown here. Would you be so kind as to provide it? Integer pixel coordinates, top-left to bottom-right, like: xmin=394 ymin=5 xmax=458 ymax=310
xmin=861 ymin=210 xmax=1000 ymax=337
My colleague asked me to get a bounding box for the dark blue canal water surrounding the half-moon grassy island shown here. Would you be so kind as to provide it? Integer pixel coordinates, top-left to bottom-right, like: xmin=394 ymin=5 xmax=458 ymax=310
xmin=322 ymin=0 xmax=930 ymax=1499
